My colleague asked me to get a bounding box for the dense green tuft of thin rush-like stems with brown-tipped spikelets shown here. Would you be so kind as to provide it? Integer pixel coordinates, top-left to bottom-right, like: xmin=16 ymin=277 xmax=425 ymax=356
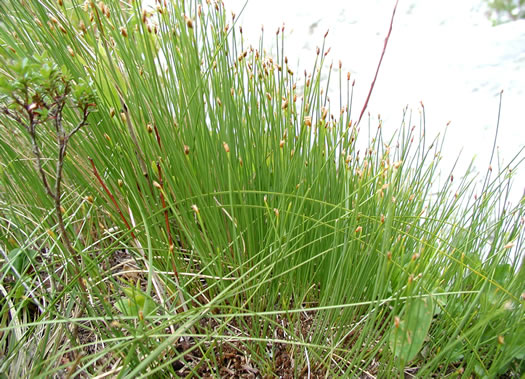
xmin=0 ymin=0 xmax=525 ymax=377
